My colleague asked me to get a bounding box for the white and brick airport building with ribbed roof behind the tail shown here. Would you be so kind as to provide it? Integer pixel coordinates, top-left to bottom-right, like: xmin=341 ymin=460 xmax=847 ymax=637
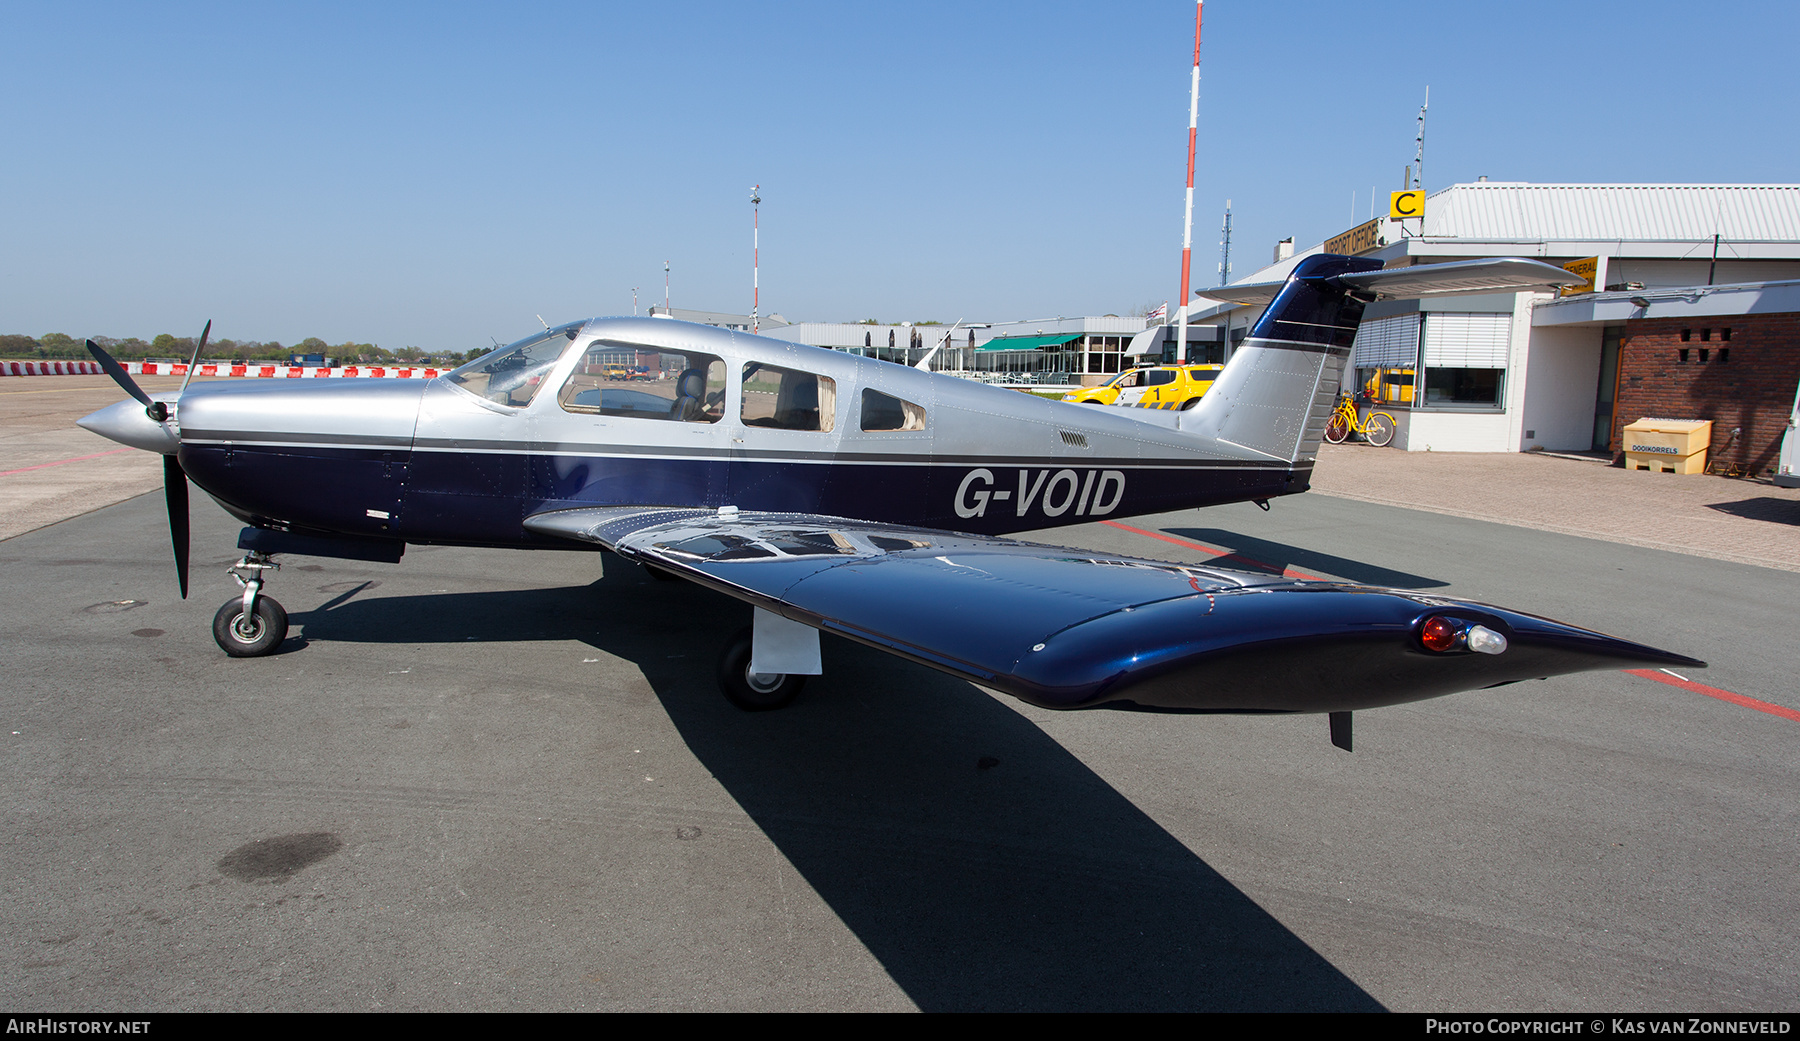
xmin=1190 ymin=182 xmax=1800 ymax=465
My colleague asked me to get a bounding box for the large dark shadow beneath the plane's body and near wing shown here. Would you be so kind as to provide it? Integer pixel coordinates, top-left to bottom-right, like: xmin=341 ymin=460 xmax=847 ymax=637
xmin=292 ymin=557 xmax=1381 ymax=1010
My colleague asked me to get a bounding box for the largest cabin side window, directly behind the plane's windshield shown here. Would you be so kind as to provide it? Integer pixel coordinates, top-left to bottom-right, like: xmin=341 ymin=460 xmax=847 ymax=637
xmin=556 ymin=340 xmax=725 ymax=423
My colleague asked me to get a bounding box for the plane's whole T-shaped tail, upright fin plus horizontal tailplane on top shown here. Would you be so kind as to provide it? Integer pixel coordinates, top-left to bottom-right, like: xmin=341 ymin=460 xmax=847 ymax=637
xmin=1179 ymin=254 xmax=1582 ymax=468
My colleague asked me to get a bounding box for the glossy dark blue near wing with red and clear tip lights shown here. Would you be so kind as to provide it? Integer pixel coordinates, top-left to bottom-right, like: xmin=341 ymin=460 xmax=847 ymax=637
xmin=526 ymin=506 xmax=1705 ymax=711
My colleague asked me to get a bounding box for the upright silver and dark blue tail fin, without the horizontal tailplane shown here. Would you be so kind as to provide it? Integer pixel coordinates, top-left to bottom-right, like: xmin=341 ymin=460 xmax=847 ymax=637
xmin=1179 ymin=254 xmax=1381 ymax=463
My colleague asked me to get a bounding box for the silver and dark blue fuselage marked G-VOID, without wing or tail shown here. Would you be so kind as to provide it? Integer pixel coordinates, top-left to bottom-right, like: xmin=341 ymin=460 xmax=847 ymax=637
xmin=165 ymin=319 xmax=1310 ymax=546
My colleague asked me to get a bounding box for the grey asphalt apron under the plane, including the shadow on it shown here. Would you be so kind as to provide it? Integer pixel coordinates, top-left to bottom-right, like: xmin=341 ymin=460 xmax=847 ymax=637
xmin=0 ymin=482 xmax=1800 ymax=1012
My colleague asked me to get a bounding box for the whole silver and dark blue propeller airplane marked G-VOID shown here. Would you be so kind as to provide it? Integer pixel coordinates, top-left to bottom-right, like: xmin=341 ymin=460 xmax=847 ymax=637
xmin=81 ymin=256 xmax=1703 ymax=747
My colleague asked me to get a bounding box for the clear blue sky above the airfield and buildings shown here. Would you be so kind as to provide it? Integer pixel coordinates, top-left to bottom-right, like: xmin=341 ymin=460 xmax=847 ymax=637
xmin=0 ymin=0 xmax=1800 ymax=349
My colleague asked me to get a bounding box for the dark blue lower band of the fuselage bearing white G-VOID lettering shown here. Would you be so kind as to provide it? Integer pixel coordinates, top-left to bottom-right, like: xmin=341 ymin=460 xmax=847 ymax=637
xmin=180 ymin=443 xmax=1310 ymax=546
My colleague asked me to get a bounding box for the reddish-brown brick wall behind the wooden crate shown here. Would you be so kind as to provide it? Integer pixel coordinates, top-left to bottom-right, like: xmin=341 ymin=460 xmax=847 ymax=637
xmin=1613 ymin=313 xmax=1800 ymax=474
